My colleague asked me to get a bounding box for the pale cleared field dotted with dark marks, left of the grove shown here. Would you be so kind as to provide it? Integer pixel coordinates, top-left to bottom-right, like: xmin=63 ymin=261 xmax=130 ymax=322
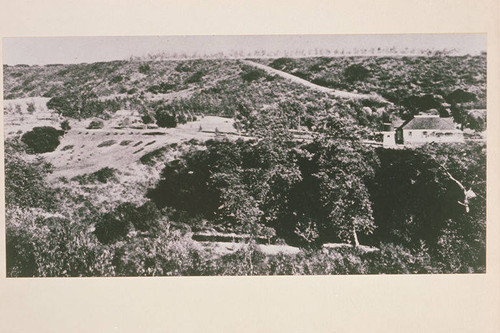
xmin=43 ymin=117 xmax=235 ymax=178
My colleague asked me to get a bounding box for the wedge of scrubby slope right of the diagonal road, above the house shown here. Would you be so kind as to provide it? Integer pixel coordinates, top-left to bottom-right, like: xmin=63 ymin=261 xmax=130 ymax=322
xmin=259 ymin=55 xmax=486 ymax=108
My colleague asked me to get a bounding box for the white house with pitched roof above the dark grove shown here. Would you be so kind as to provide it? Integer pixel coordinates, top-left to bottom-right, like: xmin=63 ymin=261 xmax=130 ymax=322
xmin=383 ymin=114 xmax=464 ymax=147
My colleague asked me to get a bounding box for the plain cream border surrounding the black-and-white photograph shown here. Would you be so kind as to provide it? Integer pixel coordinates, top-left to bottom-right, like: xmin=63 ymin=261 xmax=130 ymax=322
xmin=0 ymin=0 xmax=500 ymax=332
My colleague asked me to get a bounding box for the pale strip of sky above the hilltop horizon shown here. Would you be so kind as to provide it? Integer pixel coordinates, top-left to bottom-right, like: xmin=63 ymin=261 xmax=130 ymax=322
xmin=2 ymin=34 xmax=486 ymax=65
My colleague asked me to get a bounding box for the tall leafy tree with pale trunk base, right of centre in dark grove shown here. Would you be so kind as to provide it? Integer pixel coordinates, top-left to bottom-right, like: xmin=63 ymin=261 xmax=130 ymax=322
xmin=314 ymin=115 xmax=376 ymax=246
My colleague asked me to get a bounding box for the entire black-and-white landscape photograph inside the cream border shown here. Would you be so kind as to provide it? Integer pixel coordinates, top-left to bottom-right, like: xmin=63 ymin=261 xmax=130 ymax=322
xmin=3 ymin=33 xmax=487 ymax=278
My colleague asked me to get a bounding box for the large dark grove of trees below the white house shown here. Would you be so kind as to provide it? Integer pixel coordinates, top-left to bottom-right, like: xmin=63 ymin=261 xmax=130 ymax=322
xmin=148 ymin=117 xmax=486 ymax=272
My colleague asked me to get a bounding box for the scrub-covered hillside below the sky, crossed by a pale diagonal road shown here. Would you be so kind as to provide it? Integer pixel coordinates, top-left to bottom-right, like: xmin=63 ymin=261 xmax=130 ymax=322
xmin=4 ymin=55 xmax=486 ymax=130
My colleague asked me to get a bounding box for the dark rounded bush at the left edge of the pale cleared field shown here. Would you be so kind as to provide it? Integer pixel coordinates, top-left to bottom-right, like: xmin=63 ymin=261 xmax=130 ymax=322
xmin=21 ymin=126 xmax=64 ymax=154
